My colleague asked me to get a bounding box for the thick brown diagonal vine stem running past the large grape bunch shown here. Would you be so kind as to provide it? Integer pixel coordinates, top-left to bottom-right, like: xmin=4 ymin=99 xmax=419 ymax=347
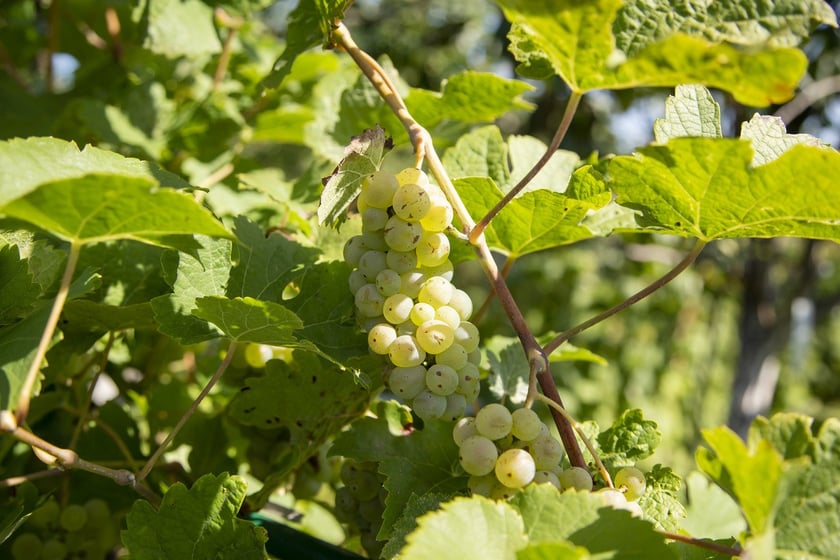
xmin=332 ymin=22 xmax=586 ymax=468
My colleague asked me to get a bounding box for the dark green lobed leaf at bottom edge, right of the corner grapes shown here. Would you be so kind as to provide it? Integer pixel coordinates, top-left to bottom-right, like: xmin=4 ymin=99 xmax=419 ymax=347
xmin=122 ymin=473 xmax=266 ymax=560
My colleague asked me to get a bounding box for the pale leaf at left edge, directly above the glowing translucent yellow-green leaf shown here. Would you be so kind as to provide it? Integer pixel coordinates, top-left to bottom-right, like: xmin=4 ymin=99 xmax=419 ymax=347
xmin=0 ymin=137 xmax=189 ymax=208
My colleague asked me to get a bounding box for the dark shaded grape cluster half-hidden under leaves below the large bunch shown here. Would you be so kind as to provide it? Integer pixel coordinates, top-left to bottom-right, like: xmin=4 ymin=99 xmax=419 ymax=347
xmin=335 ymin=460 xmax=388 ymax=558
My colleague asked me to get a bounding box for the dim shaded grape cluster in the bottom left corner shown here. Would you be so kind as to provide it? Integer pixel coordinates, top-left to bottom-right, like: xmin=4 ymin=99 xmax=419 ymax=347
xmin=11 ymin=498 xmax=119 ymax=560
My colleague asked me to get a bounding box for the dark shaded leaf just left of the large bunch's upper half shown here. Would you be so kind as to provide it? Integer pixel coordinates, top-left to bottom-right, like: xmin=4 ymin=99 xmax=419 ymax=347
xmin=228 ymin=216 xmax=318 ymax=302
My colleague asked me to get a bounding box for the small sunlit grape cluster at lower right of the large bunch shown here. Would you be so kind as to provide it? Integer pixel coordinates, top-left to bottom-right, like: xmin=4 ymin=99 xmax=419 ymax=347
xmin=452 ymin=403 xmax=568 ymax=499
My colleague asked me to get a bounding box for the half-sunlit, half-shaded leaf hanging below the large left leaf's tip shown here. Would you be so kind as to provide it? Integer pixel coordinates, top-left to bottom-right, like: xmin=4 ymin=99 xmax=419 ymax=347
xmin=151 ymin=237 xmax=231 ymax=344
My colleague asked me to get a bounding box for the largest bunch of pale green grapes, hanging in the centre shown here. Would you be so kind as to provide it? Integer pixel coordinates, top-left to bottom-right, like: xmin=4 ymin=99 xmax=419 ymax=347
xmin=344 ymin=168 xmax=480 ymax=421
